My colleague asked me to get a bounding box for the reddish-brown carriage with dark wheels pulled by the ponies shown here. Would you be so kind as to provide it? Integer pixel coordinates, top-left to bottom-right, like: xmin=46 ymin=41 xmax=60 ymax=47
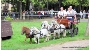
xmin=56 ymin=16 xmax=79 ymax=37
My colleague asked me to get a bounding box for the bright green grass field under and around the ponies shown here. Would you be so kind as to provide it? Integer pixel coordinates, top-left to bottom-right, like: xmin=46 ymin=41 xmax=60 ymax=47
xmin=1 ymin=21 xmax=89 ymax=50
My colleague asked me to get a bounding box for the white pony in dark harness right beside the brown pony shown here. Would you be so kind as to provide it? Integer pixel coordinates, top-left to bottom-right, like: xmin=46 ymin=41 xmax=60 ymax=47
xmin=30 ymin=27 xmax=50 ymax=44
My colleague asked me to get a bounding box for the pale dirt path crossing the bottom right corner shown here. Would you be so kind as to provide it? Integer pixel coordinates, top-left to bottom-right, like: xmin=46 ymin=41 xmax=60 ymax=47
xmin=29 ymin=40 xmax=89 ymax=50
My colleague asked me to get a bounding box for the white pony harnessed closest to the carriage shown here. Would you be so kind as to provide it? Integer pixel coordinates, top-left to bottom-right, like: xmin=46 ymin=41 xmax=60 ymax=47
xmin=51 ymin=20 xmax=66 ymax=39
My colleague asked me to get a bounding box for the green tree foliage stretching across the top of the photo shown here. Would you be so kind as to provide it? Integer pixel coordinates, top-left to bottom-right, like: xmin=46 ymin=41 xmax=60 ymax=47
xmin=1 ymin=0 xmax=89 ymax=11
